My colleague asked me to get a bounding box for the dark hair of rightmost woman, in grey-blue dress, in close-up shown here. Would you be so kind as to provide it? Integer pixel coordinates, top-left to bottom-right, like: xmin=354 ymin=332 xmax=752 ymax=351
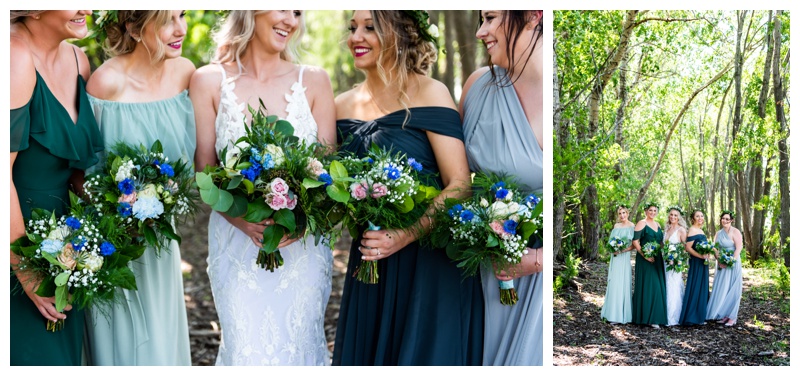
xmin=478 ymin=10 xmax=544 ymax=86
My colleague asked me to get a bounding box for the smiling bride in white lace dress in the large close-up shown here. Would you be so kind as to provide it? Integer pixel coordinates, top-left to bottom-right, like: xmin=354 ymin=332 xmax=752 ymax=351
xmin=189 ymin=10 xmax=336 ymax=365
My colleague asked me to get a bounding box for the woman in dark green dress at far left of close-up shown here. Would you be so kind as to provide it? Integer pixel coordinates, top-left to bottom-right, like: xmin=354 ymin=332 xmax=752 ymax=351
xmin=8 ymin=10 xmax=103 ymax=366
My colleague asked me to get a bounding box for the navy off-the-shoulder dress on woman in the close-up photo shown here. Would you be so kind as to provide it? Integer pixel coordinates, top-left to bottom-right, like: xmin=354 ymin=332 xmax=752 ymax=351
xmin=333 ymin=107 xmax=484 ymax=366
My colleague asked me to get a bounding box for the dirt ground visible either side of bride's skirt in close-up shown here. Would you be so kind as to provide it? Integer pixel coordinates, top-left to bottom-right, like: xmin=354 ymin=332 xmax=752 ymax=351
xmin=179 ymin=205 xmax=350 ymax=366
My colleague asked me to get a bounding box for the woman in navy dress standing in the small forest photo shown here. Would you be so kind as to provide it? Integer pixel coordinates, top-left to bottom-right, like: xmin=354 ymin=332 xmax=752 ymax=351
xmin=680 ymin=210 xmax=708 ymax=325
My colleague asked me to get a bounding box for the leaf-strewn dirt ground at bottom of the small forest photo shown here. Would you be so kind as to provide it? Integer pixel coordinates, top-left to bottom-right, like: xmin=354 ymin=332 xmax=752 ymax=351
xmin=553 ymin=263 xmax=790 ymax=366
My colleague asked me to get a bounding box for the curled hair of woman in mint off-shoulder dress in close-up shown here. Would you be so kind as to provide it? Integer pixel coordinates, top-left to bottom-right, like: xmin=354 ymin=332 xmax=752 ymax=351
xmin=103 ymin=10 xmax=172 ymax=64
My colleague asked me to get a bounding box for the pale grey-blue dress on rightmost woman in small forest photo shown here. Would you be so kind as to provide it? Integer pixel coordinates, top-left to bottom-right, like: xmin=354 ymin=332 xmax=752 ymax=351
xmin=706 ymin=230 xmax=742 ymax=322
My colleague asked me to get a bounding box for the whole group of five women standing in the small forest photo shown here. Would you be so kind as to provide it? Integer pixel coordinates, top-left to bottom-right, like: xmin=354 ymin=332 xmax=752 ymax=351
xmin=601 ymin=202 xmax=742 ymax=329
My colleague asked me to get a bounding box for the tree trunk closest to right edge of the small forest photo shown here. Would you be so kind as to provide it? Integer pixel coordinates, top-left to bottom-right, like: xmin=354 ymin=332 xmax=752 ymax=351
xmin=772 ymin=10 xmax=790 ymax=267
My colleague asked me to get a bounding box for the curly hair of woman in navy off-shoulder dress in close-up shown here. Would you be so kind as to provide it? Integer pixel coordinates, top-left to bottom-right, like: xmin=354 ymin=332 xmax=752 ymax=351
xmin=369 ymin=10 xmax=438 ymax=119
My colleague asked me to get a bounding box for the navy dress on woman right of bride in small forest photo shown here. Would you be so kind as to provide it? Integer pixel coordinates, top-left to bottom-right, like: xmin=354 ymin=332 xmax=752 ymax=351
xmin=680 ymin=234 xmax=708 ymax=325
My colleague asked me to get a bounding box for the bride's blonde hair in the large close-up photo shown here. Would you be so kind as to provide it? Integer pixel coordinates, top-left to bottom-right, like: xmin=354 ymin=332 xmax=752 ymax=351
xmin=211 ymin=10 xmax=306 ymax=76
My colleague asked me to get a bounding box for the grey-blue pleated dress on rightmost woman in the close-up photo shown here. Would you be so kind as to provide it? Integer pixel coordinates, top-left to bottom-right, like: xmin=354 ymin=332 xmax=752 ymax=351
xmin=464 ymin=67 xmax=544 ymax=366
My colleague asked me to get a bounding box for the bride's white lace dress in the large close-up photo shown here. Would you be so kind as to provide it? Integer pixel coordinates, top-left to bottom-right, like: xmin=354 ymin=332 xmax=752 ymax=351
xmin=208 ymin=67 xmax=333 ymax=365
